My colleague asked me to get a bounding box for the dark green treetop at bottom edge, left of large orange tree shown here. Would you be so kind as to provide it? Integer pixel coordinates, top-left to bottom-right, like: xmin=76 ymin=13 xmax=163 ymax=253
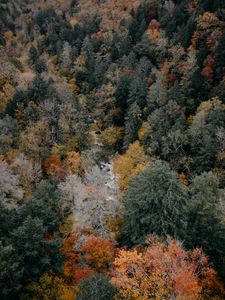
xmin=76 ymin=274 xmax=116 ymax=300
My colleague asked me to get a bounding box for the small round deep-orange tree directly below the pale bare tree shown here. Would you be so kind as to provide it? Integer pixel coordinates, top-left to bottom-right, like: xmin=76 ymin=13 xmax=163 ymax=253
xmin=80 ymin=236 xmax=116 ymax=272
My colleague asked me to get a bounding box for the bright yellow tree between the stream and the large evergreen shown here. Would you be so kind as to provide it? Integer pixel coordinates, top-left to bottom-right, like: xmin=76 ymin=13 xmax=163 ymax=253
xmin=114 ymin=141 xmax=147 ymax=190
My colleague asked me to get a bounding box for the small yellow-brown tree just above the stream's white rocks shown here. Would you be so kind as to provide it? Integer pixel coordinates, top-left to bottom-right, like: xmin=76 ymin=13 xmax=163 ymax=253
xmin=99 ymin=126 xmax=124 ymax=146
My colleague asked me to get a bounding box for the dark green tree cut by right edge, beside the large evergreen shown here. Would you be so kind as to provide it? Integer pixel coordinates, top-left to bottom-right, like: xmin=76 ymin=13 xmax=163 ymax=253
xmin=186 ymin=172 xmax=225 ymax=276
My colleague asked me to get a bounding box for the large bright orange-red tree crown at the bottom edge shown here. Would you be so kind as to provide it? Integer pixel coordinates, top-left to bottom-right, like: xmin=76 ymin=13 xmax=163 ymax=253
xmin=112 ymin=240 xmax=221 ymax=300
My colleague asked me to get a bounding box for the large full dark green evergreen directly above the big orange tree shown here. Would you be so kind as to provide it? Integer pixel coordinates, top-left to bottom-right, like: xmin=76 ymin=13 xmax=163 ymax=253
xmin=124 ymin=161 xmax=188 ymax=244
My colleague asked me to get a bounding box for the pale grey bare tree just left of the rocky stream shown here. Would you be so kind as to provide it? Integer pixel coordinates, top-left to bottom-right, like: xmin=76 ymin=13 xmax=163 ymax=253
xmin=59 ymin=166 xmax=121 ymax=236
